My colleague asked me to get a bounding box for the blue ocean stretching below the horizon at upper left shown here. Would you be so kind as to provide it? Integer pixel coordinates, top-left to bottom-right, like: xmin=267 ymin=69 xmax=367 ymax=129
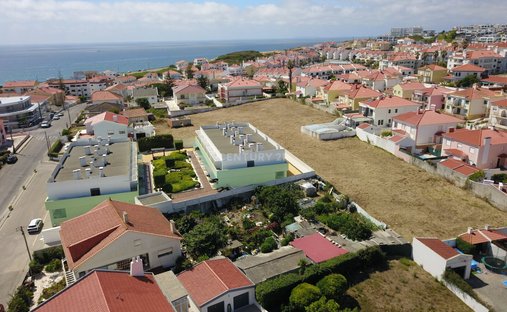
xmin=0 ymin=38 xmax=347 ymax=84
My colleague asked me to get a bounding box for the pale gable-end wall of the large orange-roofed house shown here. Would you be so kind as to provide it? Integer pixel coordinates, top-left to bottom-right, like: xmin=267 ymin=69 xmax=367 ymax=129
xmin=73 ymin=231 xmax=181 ymax=276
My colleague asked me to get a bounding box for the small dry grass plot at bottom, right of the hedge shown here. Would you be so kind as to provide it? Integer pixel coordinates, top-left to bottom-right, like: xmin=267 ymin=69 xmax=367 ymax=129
xmin=347 ymin=260 xmax=471 ymax=312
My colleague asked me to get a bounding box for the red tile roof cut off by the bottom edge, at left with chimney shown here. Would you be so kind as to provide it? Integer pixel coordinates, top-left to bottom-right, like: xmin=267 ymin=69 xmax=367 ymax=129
xmin=33 ymin=270 xmax=174 ymax=312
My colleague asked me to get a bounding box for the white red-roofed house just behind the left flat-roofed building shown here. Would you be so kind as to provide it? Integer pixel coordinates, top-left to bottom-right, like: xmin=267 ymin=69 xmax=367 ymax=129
xmin=84 ymin=112 xmax=128 ymax=140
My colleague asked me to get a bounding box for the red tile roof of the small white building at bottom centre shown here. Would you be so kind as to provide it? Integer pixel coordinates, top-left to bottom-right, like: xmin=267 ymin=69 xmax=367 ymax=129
xmin=178 ymin=258 xmax=254 ymax=307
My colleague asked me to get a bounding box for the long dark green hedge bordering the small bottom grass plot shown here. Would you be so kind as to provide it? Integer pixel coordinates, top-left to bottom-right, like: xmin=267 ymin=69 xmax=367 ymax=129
xmin=255 ymin=246 xmax=386 ymax=310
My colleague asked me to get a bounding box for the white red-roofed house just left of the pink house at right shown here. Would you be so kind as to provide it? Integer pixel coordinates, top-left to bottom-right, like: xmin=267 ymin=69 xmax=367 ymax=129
xmin=392 ymin=110 xmax=462 ymax=149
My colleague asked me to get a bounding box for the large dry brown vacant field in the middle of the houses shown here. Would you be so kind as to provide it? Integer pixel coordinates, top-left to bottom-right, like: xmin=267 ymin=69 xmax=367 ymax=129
xmin=157 ymin=99 xmax=507 ymax=239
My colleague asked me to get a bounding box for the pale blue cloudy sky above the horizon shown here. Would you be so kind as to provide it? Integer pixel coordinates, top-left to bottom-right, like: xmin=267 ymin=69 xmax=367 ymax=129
xmin=0 ymin=0 xmax=507 ymax=45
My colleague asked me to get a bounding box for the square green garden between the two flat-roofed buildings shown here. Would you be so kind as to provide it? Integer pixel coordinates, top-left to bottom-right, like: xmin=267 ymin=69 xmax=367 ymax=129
xmin=152 ymin=151 xmax=199 ymax=193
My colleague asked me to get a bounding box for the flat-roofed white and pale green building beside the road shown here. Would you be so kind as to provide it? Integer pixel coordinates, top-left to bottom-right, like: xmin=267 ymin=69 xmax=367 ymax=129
xmin=45 ymin=140 xmax=138 ymax=226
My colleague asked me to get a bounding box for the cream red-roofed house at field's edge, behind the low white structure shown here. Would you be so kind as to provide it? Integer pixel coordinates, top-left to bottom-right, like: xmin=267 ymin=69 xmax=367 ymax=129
xmin=359 ymin=96 xmax=419 ymax=127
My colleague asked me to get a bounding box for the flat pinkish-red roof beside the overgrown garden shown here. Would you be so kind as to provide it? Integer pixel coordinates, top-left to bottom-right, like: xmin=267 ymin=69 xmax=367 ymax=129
xmin=290 ymin=233 xmax=347 ymax=263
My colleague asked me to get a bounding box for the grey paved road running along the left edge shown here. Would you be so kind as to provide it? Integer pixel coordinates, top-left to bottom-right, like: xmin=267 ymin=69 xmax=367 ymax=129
xmin=0 ymin=104 xmax=84 ymax=305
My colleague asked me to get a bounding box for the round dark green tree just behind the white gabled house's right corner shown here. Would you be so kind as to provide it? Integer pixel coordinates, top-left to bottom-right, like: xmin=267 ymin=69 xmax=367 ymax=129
xmin=183 ymin=218 xmax=227 ymax=259
